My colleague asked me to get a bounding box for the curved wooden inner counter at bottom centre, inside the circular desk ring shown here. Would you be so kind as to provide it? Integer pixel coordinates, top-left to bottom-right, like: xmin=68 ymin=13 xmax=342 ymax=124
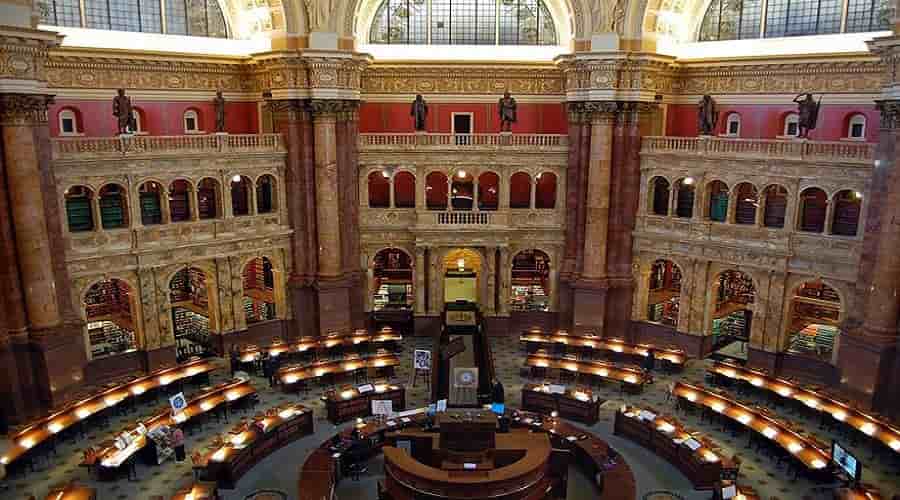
xmin=383 ymin=431 xmax=552 ymax=500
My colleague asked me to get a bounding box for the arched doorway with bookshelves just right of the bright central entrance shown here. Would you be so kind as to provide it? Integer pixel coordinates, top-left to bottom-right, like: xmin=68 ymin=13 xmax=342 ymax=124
xmin=510 ymin=250 xmax=550 ymax=311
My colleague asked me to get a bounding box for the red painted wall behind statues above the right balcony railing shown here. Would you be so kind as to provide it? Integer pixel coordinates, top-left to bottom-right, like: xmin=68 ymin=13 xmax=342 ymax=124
xmin=666 ymin=101 xmax=880 ymax=142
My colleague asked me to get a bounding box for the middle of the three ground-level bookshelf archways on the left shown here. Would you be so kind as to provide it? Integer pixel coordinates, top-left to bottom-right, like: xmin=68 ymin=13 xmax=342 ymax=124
xmin=169 ymin=267 xmax=210 ymax=359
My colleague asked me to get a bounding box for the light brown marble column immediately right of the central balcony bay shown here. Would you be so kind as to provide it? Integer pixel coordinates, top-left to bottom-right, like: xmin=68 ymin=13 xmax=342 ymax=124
xmin=573 ymin=102 xmax=618 ymax=333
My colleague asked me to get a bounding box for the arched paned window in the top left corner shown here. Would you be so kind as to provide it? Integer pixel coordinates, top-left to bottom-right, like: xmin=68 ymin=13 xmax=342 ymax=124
xmin=41 ymin=0 xmax=228 ymax=38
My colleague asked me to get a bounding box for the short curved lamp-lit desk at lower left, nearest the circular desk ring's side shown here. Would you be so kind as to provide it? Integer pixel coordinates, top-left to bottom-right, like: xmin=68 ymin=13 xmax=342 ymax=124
xmin=200 ymin=403 xmax=313 ymax=489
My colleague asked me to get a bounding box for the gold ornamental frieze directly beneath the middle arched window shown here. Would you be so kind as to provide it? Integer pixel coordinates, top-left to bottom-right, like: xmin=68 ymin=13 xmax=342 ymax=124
xmin=362 ymin=64 xmax=564 ymax=95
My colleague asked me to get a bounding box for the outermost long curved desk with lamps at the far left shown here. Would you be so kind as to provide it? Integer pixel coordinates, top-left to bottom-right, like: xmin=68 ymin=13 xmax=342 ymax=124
xmin=0 ymin=358 xmax=216 ymax=468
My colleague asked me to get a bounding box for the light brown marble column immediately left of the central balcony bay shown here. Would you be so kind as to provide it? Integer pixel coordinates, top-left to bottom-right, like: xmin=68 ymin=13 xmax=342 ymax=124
xmin=311 ymin=100 xmax=354 ymax=334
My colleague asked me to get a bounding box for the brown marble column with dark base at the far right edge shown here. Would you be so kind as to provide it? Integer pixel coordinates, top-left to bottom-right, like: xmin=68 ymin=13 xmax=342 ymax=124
xmin=838 ymin=101 xmax=900 ymax=415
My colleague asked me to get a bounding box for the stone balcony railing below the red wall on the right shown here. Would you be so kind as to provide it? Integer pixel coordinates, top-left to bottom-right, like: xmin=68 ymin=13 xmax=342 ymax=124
xmin=641 ymin=137 xmax=875 ymax=165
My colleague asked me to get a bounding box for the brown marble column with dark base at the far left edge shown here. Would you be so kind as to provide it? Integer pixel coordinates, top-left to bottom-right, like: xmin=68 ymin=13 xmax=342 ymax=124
xmin=0 ymin=94 xmax=86 ymax=406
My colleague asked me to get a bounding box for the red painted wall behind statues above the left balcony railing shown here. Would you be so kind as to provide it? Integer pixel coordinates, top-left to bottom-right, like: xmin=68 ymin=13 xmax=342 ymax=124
xmin=49 ymin=98 xmax=259 ymax=137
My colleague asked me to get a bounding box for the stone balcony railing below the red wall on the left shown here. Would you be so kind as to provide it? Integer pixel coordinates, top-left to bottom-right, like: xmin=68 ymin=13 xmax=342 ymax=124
xmin=52 ymin=134 xmax=286 ymax=160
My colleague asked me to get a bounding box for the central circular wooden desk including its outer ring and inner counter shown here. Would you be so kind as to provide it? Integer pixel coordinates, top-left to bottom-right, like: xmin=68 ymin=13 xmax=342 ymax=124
xmin=299 ymin=409 xmax=637 ymax=500
